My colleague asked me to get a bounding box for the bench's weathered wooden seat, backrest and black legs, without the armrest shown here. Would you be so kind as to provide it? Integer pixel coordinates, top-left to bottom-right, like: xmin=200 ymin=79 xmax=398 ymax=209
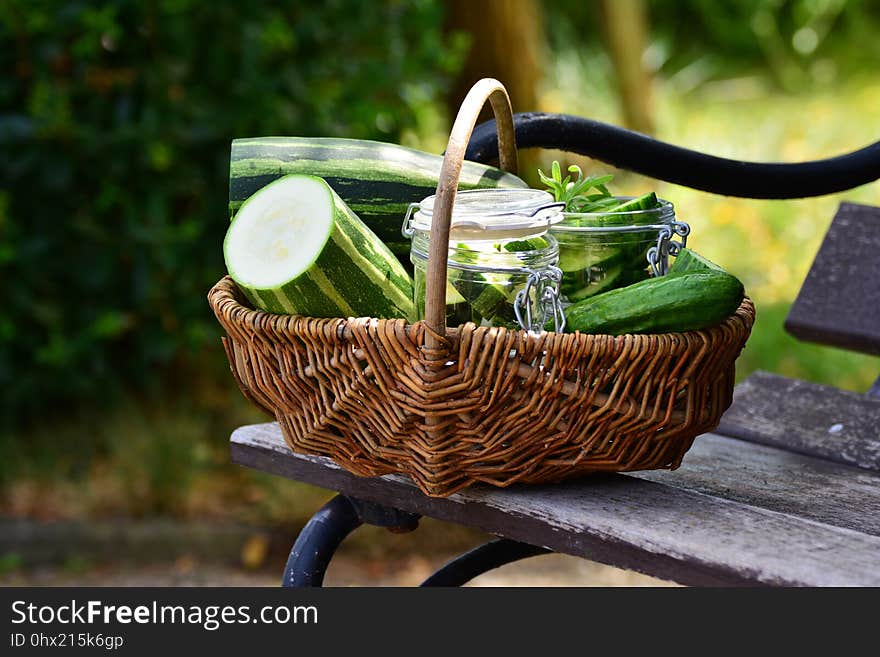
xmin=231 ymin=116 xmax=880 ymax=586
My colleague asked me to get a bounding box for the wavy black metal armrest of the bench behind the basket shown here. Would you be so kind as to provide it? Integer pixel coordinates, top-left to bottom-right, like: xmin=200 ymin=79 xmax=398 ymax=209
xmin=465 ymin=112 xmax=880 ymax=199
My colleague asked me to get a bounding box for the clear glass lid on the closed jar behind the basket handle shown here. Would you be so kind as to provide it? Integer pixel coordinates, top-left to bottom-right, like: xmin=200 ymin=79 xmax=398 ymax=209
xmin=404 ymin=188 xmax=565 ymax=240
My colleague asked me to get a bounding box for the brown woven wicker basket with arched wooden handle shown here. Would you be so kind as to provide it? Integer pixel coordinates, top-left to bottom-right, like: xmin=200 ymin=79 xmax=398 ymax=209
xmin=208 ymin=79 xmax=755 ymax=497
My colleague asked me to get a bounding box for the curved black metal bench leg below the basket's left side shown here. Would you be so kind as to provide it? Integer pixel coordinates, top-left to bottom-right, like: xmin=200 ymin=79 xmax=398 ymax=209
xmin=281 ymin=495 xmax=419 ymax=587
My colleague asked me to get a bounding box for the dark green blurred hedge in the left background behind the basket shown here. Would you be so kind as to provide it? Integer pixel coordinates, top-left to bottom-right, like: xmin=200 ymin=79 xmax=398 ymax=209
xmin=0 ymin=0 xmax=457 ymax=428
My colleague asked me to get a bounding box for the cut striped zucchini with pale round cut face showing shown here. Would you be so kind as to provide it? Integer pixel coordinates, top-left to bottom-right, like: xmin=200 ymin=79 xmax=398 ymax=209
xmin=223 ymin=174 xmax=416 ymax=320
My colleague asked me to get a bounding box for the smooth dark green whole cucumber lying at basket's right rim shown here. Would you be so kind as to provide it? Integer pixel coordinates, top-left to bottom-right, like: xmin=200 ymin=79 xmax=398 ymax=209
xmin=565 ymin=271 xmax=744 ymax=335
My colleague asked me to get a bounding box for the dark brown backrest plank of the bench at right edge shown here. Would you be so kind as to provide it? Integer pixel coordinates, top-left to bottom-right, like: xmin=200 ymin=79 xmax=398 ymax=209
xmin=785 ymin=203 xmax=880 ymax=354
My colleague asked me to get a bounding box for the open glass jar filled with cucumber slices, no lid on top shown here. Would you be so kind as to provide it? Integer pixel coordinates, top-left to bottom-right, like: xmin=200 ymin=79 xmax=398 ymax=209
xmin=550 ymin=196 xmax=690 ymax=305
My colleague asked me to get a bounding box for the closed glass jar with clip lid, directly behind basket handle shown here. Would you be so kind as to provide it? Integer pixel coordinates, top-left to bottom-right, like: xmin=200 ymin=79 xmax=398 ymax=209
xmin=403 ymin=189 xmax=565 ymax=332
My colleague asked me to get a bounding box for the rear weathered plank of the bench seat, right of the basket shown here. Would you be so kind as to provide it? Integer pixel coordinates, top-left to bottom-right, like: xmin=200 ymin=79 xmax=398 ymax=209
xmin=717 ymin=372 xmax=880 ymax=471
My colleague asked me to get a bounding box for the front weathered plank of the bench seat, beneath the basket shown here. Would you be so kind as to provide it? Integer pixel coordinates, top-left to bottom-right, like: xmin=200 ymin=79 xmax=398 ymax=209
xmin=232 ymin=423 xmax=880 ymax=586
